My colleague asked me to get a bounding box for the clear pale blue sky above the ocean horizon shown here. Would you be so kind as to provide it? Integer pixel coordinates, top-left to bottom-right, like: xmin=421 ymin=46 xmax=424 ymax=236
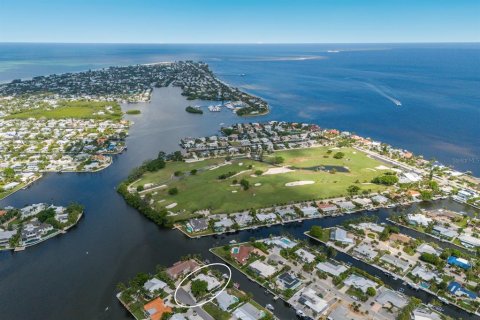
xmin=0 ymin=0 xmax=480 ymax=43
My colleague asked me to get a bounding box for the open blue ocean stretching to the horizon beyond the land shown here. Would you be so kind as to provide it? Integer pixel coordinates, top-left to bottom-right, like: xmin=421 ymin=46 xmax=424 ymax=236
xmin=0 ymin=43 xmax=480 ymax=175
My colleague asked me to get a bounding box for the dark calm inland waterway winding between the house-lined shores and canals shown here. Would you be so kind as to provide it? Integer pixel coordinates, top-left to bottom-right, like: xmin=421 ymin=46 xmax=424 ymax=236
xmin=0 ymin=88 xmax=478 ymax=319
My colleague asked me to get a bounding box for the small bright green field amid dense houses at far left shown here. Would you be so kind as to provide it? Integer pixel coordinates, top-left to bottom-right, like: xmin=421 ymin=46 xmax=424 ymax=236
xmin=6 ymin=100 xmax=122 ymax=120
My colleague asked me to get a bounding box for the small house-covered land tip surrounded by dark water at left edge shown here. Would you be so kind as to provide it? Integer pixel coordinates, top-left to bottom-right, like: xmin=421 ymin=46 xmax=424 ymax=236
xmin=0 ymin=203 xmax=83 ymax=251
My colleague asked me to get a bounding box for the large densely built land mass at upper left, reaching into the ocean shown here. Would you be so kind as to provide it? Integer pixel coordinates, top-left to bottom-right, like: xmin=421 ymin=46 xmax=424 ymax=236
xmin=0 ymin=61 xmax=268 ymax=199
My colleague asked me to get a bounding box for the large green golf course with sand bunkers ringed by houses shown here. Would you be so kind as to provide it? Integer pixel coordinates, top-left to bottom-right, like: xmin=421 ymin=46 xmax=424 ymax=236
xmin=133 ymin=147 xmax=392 ymax=218
